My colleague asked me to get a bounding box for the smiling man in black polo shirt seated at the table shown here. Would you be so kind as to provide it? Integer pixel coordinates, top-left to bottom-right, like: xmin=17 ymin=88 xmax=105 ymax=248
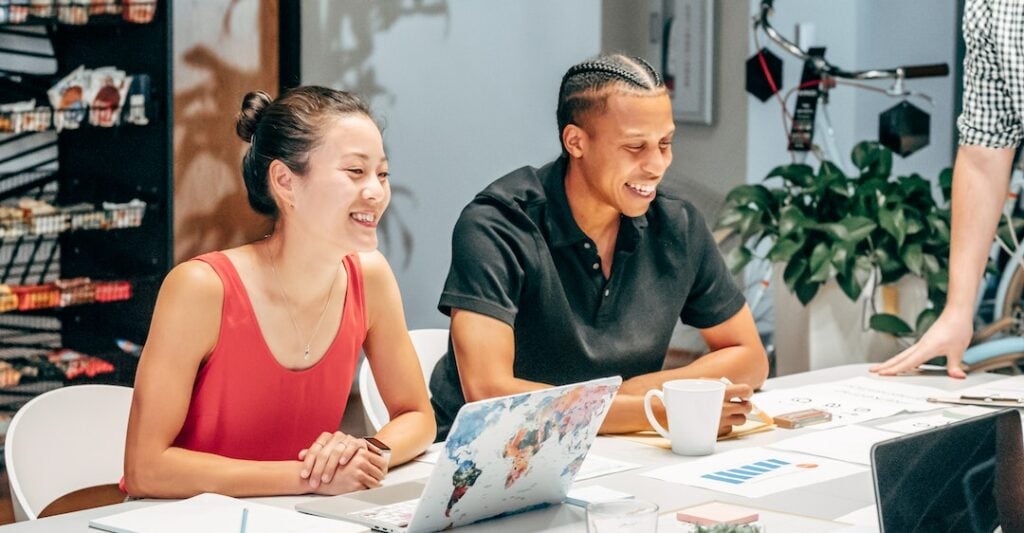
xmin=430 ymin=55 xmax=768 ymax=439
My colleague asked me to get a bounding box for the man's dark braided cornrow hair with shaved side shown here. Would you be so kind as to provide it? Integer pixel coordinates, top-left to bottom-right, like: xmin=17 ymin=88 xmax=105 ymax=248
xmin=557 ymin=54 xmax=665 ymax=153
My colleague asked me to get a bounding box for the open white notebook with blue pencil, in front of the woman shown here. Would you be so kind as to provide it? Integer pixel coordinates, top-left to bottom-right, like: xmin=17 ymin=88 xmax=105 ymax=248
xmin=89 ymin=493 xmax=367 ymax=533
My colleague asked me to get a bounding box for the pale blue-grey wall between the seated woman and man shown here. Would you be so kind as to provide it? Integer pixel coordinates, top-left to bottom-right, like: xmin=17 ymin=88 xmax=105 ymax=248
xmin=302 ymin=0 xmax=601 ymax=328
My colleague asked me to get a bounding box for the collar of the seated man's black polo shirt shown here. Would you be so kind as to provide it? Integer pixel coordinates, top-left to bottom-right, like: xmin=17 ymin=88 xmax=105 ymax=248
xmin=538 ymin=156 xmax=647 ymax=253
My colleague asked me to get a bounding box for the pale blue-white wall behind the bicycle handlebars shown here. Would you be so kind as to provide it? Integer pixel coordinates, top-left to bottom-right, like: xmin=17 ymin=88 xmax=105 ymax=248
xmin=746 ymin=0 xmax=959 ymax=182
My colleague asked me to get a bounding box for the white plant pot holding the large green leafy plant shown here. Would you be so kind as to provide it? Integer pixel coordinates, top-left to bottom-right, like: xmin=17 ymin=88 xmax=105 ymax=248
xmin=772 ymin=264 xmax=928 ymax=375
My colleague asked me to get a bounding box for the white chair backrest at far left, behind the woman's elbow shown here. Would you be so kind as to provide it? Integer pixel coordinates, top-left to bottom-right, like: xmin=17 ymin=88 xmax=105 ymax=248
xmin=4 ymin=385 xmax=132 ymax=521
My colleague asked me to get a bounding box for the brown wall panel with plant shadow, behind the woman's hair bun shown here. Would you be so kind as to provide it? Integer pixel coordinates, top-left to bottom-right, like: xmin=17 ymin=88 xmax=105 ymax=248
xmin=174 ymin=0 xmax=278 ymax=262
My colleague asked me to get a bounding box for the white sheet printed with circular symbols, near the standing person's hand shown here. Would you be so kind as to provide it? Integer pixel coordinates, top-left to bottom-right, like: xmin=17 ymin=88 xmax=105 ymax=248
xmin=752 ymin=377 xmax=943 ymax=430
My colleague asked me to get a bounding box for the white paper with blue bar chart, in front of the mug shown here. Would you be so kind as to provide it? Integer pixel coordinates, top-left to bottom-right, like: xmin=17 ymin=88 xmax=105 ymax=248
xmin=640 ymin=447 xmax=867 ymax=498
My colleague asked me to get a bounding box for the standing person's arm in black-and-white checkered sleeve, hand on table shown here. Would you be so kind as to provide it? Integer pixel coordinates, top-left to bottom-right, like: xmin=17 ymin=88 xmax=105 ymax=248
xmin=871 ymin=0 xmax=1024 ymax=379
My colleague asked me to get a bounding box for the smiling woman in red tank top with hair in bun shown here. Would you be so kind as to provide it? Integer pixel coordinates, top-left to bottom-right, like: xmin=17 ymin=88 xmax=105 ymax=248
xmin=124 ymin=87 xmax=435 ymax=498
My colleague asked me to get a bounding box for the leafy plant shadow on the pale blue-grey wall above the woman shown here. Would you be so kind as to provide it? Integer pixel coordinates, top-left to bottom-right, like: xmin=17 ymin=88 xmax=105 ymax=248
xmin=302 ymin=0 xmax=451 ymax=269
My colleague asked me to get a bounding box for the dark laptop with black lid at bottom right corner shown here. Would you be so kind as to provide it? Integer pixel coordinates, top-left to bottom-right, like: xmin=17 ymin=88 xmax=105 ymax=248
xmin=871 ymin=409 xmax=1024 ymax=533
